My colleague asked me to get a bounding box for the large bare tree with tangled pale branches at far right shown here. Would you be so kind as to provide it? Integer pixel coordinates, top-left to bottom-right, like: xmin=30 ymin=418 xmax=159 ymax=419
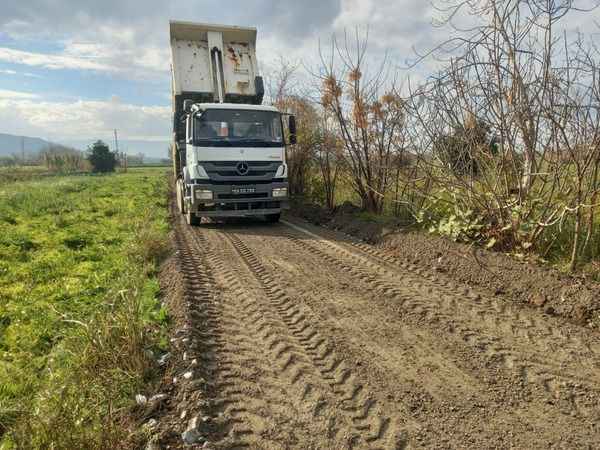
xmin=410 ymin=0 xmax=598 ymax=268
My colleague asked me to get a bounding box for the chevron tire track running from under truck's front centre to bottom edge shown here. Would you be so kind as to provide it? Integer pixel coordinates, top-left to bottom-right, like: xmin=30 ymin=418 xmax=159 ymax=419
xmin=209 ymin=232 xmax=408 ymax=449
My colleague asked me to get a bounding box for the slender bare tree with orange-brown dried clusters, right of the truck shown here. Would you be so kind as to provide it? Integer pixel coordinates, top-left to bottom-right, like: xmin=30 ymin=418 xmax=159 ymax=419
xmin=316 ymin=29 xmax=405 ymax=213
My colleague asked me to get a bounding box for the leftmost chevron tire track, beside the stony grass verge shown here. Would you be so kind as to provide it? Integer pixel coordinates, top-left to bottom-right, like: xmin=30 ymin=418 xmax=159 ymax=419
xmin=177 ymin=219 xmax=278 ymax=447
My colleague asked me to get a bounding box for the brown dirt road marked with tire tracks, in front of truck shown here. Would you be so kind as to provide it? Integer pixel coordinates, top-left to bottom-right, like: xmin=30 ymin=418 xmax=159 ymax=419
xmin=166 ymin=216 xmax=600 ymax=449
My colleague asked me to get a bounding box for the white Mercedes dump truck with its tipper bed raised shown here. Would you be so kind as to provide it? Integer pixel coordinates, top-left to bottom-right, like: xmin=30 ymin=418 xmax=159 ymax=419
xmin=170 ymin=21 xmax=296 ymax=225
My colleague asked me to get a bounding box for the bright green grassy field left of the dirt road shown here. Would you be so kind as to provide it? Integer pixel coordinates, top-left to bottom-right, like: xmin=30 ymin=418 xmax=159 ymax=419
xmin=0 ymin=168 xmax=168 ymax=448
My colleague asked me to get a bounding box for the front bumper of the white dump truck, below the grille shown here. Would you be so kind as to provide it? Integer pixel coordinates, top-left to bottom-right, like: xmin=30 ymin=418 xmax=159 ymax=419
xmin=185 ymin=182 xmax=289 ymax=217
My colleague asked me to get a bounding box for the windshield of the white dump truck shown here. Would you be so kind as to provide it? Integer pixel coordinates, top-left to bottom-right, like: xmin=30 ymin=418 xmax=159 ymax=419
xmin=194 ymin=109 xmax=283 ymax=147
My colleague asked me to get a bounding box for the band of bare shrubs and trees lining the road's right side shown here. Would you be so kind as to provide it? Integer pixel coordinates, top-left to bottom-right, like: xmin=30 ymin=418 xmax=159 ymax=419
xmin=271 ymin=0 xmax=600 ymax=276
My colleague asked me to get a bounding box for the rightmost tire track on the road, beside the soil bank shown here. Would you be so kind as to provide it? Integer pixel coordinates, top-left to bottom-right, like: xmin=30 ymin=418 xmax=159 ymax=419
xmin=280 ymin=220 xmax=600 ymax=414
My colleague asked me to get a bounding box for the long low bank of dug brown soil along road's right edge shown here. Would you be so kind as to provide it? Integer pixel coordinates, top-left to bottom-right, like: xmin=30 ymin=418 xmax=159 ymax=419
xmin=293 ymin=204 xmax=600 ymax=329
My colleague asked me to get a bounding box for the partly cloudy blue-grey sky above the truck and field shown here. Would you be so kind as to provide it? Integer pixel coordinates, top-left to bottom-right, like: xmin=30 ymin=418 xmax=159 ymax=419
xmin=0 ymin=0 xmax=600 ymax=157
